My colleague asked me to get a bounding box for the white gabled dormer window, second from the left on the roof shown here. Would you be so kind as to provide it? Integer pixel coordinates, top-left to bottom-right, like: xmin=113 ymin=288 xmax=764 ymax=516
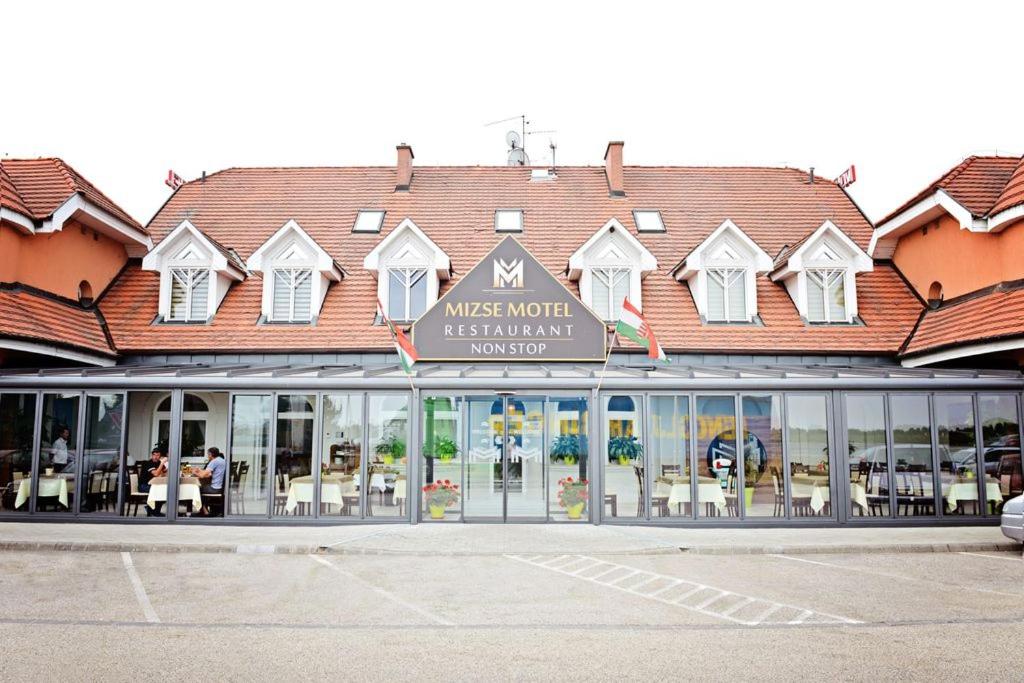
xmin=247 ymin=220 xmax=344 ymax=324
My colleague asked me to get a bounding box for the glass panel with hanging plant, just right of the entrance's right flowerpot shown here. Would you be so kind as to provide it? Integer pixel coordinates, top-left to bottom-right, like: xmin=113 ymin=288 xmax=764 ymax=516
xmin=601 ymin=395 xmax=645 ymax=517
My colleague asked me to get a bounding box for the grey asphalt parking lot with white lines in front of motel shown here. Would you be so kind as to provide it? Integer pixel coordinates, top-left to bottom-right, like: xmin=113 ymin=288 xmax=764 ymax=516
xmin=0 ymin=551 xmax=1024 ymax=681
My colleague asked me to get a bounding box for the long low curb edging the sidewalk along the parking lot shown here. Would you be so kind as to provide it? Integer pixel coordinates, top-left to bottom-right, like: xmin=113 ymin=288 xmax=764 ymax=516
xmin=0 ymin=541 xmax=1022 ymax=557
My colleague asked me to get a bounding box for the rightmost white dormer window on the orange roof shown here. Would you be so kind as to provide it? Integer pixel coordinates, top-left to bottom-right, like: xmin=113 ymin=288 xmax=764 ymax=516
xmin=771 ymin=220 xmax=874 ymax=325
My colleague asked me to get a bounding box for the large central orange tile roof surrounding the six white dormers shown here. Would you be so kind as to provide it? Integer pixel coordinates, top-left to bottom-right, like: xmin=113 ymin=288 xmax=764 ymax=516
xmin=99 ymin=166 xmax=921 ymax=353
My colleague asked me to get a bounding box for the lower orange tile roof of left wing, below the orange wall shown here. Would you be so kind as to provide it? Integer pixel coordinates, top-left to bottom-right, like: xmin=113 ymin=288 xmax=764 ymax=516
xmin=0 ymin=285 xmax=115 ymax=356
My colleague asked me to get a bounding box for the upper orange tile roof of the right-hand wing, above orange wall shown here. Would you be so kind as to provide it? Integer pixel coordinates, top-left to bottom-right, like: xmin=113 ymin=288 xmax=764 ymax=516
xmin=879 ymin=157 xmax=1024 ymax=225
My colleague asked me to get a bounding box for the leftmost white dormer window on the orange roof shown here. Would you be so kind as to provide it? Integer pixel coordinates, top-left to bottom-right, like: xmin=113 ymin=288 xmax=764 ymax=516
xmin=142 ymin=220 xmax=246 ymax=323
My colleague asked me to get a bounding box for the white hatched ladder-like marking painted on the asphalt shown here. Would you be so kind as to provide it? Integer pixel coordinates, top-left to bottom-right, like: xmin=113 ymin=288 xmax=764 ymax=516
xmin=506 ymin=555 xmax=860 ymax=626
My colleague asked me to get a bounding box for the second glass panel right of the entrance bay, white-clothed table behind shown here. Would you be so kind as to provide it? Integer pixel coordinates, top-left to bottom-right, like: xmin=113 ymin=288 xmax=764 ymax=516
xmin=647 ymin=396 xmax=693 ymax=518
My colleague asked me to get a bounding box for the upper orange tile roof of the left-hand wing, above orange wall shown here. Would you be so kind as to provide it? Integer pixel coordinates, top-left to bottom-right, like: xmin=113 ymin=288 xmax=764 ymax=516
xmin=0 ymin=157 xmax=145 ymax=232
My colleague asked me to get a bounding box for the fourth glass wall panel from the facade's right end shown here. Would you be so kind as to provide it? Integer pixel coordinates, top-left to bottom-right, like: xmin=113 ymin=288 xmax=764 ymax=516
xmin=846 ymin=393 xmax=890 ymax=517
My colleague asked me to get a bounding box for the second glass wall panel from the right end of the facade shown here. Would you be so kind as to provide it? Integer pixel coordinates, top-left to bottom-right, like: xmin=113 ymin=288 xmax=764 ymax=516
xmin=937 ymin=394 xmax=974 ymax=515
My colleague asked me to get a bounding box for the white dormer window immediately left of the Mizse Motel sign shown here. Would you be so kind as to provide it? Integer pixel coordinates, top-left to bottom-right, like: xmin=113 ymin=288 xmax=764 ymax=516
xmin=362 ymin=218 xmax=452 ymax=323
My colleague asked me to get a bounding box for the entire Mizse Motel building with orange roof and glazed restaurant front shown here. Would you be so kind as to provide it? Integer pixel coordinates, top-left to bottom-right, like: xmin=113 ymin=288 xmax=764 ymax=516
xmin=0 ymin=142 xmax=1024 ymax=526
